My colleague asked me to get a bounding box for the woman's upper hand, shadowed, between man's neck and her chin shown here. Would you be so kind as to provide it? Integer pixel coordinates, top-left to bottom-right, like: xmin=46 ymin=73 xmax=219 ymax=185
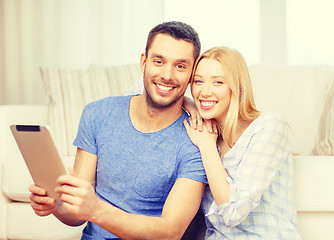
xmin=182 ymin=96 xmax=218 ymax=133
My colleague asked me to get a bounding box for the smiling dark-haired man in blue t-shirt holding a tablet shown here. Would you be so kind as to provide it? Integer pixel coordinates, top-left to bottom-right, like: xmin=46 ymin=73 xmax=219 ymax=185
xmin=30 ymin=22 xmax=207 ymax=239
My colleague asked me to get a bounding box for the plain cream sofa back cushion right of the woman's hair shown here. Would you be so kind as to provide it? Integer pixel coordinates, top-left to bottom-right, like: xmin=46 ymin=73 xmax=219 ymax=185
xmin=249 ymin=64 xmax=334 ymax=155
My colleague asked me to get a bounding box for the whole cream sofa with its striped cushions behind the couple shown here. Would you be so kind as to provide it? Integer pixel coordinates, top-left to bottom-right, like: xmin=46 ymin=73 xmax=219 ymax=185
xmin=0 ymin=64 xmax=334 ymax=240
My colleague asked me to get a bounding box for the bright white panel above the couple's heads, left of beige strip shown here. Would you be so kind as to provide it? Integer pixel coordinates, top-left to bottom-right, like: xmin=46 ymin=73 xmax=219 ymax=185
xmin=164 ymin=0 xmax=261 ymax=64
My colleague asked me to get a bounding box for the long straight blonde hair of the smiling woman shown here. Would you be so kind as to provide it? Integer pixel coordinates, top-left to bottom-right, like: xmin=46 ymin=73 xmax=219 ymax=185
xmin=191 ymin=47 xmax=260 ymax=147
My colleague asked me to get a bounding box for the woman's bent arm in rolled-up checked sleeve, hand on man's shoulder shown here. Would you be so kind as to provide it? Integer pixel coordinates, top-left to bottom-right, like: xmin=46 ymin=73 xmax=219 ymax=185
xmin=185 ymin=114 xmax=291 ymax=227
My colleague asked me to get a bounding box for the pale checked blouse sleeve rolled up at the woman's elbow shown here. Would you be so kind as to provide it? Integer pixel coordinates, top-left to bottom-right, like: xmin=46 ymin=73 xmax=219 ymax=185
xmin=208 ymin=112 xmax=291 ymax=227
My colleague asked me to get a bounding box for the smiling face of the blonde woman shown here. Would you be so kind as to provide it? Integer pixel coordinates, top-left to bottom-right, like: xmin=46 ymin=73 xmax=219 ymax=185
xmin=191 ymin=58 xmax=231 ymax=122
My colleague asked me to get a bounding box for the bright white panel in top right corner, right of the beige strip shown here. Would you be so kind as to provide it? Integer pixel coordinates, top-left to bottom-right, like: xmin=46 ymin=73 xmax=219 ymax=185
xmin=287 ymin=0 xmax=334 ymax=64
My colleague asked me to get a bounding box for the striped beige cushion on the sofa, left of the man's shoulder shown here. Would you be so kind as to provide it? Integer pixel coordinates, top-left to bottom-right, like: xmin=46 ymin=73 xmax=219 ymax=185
xmin=41 ymin=64 xmax=142 ymax=156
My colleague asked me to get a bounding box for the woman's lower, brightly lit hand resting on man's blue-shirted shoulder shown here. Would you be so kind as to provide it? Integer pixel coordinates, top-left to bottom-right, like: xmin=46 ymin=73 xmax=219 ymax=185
xmin=183 ymin=117 xmax=218 ymax=150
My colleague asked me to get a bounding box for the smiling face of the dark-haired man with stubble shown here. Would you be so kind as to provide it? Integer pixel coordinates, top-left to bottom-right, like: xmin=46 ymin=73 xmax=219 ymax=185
xmin=141 ymin=34 xmax=195 ymax=109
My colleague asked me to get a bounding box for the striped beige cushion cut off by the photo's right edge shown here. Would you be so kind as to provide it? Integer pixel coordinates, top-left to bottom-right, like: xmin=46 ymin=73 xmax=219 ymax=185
xmin=313 ymin=81 xmax=334 ymax=156
